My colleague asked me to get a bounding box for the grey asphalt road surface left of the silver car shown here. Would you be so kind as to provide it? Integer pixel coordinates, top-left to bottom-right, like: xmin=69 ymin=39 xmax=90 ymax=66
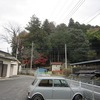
xmin=0 ymin=76 xmax=34 ymax=100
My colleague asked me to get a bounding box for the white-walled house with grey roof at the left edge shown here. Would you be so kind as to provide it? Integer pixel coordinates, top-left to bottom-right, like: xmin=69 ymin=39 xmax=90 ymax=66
xmin=0 ymin=50 xmax=20 ymax=77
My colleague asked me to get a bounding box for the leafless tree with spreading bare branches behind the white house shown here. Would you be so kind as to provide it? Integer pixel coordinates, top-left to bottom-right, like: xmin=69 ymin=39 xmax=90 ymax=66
xmin=1 ymin=23 xmax=21 ymax=58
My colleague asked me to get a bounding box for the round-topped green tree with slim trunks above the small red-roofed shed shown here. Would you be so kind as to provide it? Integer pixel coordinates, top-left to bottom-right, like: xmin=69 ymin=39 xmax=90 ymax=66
xmin=48 ymin=24 xmax=68 ymax=61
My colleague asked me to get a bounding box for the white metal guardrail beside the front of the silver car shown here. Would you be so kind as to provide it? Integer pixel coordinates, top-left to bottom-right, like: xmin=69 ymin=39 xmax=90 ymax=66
xmin=67 ymin=79 xmax=100 ymax=100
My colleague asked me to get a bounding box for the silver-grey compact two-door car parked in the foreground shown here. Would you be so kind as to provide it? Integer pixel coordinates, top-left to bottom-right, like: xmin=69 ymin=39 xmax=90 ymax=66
xmin=28 ymin=76 xmax=84 ymax=100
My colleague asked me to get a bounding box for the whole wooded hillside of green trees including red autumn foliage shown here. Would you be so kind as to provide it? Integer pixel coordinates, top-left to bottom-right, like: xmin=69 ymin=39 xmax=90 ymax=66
xmin=12 ymin=15 xmax=100 ymax=66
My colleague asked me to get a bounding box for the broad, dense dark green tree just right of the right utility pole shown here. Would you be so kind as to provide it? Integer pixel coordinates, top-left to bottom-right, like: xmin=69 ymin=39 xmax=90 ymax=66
xmin=68 ymin=28 xmax=89 ymax=62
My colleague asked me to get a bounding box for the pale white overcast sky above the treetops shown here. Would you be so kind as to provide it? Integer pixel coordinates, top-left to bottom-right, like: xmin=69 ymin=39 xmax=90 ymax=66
xmin=0 ymin=0 xmax=100 ymax=51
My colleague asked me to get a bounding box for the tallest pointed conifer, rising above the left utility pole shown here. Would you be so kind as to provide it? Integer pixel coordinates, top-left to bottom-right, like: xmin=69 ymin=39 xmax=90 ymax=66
xmin=26 ymin=16 xmax=50 ymax=54
